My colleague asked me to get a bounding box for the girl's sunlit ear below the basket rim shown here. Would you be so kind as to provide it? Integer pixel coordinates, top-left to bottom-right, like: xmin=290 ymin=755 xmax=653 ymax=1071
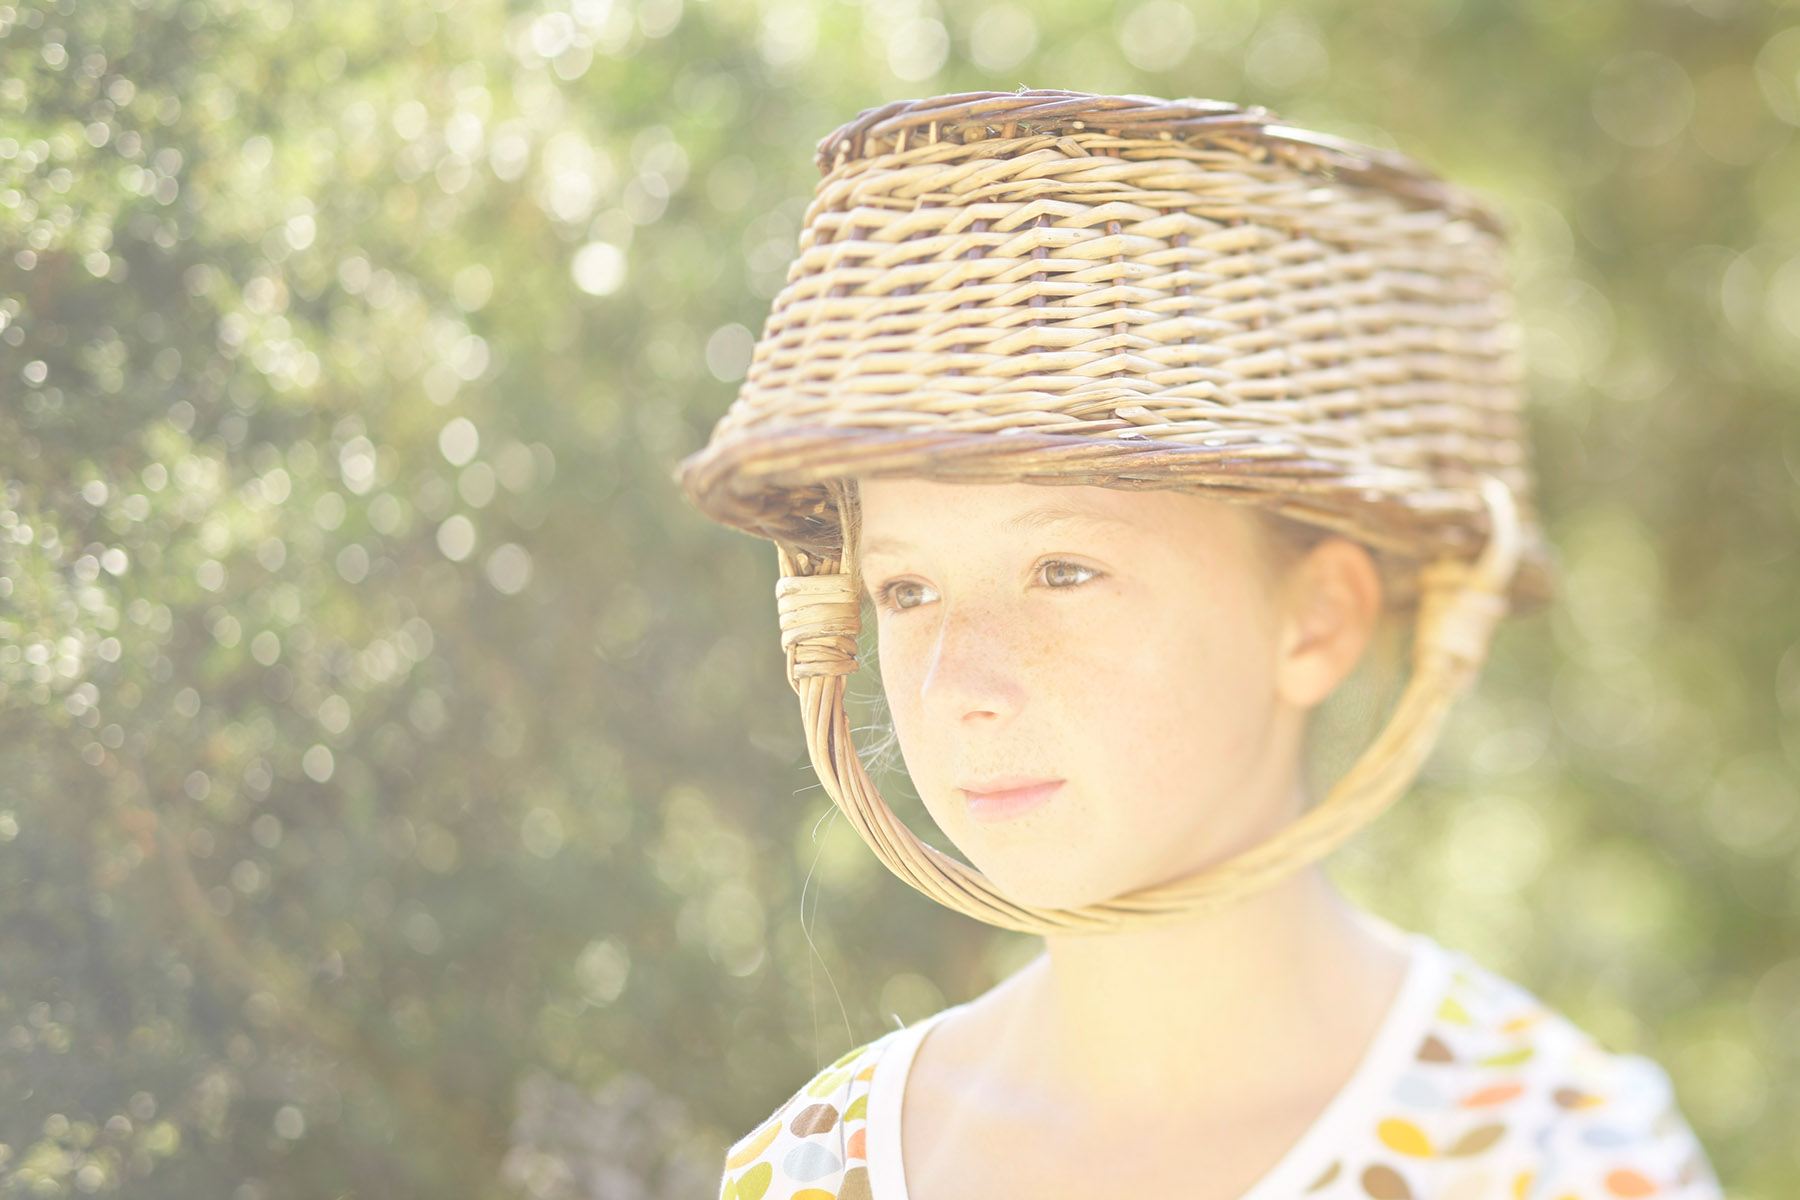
xmin=1274 ymin=536 xmax=1382 ymax=709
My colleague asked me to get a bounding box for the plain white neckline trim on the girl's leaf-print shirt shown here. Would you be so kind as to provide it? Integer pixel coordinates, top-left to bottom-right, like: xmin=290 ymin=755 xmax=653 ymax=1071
xmin=866 ymin=912 xmax=1454 ymax=1200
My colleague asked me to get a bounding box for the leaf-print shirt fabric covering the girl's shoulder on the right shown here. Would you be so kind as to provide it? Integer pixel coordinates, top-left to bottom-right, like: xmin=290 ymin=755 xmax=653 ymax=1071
xmin=1370 ymin=943 xmax=1721 ymax=1200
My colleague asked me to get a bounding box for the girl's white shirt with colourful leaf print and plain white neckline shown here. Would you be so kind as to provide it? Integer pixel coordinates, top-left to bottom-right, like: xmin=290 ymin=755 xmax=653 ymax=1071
xmin=720 ymin=932 xmax=1723 ymax=1200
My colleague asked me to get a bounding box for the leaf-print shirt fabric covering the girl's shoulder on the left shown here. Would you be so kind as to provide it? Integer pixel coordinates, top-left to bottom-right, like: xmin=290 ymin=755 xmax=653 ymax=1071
xmin=718 ymin=1029 xmax=902 ymax=1200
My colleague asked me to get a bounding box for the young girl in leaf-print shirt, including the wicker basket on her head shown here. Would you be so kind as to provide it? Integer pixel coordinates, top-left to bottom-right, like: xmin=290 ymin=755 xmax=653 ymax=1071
xmin=682 ymin=92 xmax=1721 ymax=1200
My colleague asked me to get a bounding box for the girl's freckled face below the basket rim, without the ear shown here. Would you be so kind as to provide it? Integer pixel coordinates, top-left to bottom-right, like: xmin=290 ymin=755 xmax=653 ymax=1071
xmin=860 ymin=479 xmax=1305 ymax=907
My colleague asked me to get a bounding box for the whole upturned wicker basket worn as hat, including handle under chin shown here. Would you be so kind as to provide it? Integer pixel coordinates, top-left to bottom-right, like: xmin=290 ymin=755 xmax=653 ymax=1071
xmin=679 ymin=90 xmax=1553 ymax=934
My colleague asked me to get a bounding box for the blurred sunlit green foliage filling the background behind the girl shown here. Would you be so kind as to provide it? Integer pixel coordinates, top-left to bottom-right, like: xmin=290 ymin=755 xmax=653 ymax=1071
xmin=0 ymin=0 xmax=1800 ymax=1200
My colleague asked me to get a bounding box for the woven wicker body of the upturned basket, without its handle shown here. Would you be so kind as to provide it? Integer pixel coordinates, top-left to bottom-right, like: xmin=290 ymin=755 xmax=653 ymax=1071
xmin=684 ymin=94 xmax=1548 ymax=606
